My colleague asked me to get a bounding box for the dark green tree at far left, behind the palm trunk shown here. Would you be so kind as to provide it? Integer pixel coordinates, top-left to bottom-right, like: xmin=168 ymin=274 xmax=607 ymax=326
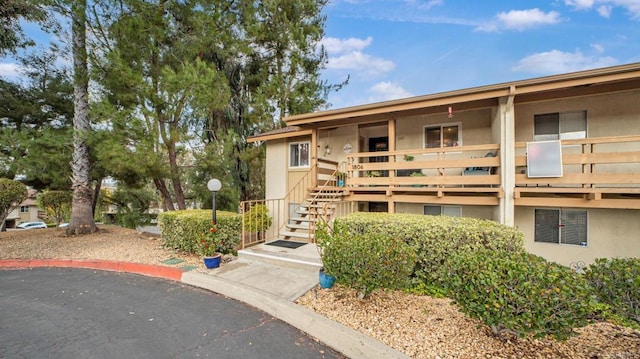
xmin=0 ymin=52 xmax=73 ymax=190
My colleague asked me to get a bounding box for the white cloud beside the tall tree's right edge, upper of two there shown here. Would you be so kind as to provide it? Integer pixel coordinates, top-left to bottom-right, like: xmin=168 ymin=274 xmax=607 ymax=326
xmin=322 ymin=37 xmax=396 ymax=75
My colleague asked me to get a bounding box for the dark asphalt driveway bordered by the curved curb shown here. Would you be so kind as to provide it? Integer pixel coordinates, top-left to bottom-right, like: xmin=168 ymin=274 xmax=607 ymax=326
xmin=0 ymin=268 xmax=343 ymax=358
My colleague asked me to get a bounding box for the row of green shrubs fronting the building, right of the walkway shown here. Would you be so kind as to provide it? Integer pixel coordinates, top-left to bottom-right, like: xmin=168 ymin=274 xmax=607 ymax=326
xmin=317 ymin=213 xmax=640 ymax=339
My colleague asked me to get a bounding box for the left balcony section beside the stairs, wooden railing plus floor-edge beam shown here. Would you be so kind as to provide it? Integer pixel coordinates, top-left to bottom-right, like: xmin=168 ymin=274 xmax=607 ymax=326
xmin=347 ymin=144 xmax=503 ymax=205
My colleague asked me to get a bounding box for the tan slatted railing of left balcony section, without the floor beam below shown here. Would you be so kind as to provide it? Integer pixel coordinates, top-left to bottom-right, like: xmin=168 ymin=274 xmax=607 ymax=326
xmin=347 ymin=144 xmax=500 ymax=189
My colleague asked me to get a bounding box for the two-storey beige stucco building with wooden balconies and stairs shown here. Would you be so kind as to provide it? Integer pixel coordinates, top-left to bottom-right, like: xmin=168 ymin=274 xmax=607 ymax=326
xmin=250 ymin=63 xmax=640 ymax=265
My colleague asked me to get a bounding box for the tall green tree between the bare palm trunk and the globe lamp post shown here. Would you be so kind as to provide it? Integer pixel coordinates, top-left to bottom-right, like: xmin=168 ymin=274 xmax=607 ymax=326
xmin=99 ymin=0 xmax=228 ymax=210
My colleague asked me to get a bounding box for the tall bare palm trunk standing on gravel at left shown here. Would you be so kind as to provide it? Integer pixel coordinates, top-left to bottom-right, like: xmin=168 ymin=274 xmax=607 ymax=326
xmin=67 ymin=0 xmax=98 ymax=234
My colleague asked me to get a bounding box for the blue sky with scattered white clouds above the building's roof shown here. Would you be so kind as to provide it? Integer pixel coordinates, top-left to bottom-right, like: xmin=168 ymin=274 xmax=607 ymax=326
xmin=323 ymin=0 xmax=640 ymax=108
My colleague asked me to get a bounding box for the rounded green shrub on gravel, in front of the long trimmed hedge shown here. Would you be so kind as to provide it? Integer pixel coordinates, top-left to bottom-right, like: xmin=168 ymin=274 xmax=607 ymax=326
xmin=439 ymin=250 xmax=592 ymax=340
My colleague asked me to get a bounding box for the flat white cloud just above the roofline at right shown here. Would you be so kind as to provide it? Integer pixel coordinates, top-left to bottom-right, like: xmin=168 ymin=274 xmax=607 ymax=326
xmin=512 ymin=50 xmax=617 ymax=74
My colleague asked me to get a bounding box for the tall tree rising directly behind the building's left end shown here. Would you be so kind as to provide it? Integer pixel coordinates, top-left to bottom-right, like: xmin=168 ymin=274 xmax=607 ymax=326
xmin=205 ymin=0 xmax=346 ymax=200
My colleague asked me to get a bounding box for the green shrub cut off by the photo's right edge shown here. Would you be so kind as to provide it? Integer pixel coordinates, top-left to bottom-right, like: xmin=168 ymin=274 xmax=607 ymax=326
xmin=585 ymin=258 xmax=640 ymax=329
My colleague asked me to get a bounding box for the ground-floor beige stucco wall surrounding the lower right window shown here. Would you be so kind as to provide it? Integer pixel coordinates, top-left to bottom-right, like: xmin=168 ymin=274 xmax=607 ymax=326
xmin=515 ymin=207 xmax=640 ymax=266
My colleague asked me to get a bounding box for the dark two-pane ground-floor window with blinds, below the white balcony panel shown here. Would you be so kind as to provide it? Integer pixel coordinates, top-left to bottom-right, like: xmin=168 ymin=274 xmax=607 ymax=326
xmin=534 ymin=209 xmax=588 ymax=246
